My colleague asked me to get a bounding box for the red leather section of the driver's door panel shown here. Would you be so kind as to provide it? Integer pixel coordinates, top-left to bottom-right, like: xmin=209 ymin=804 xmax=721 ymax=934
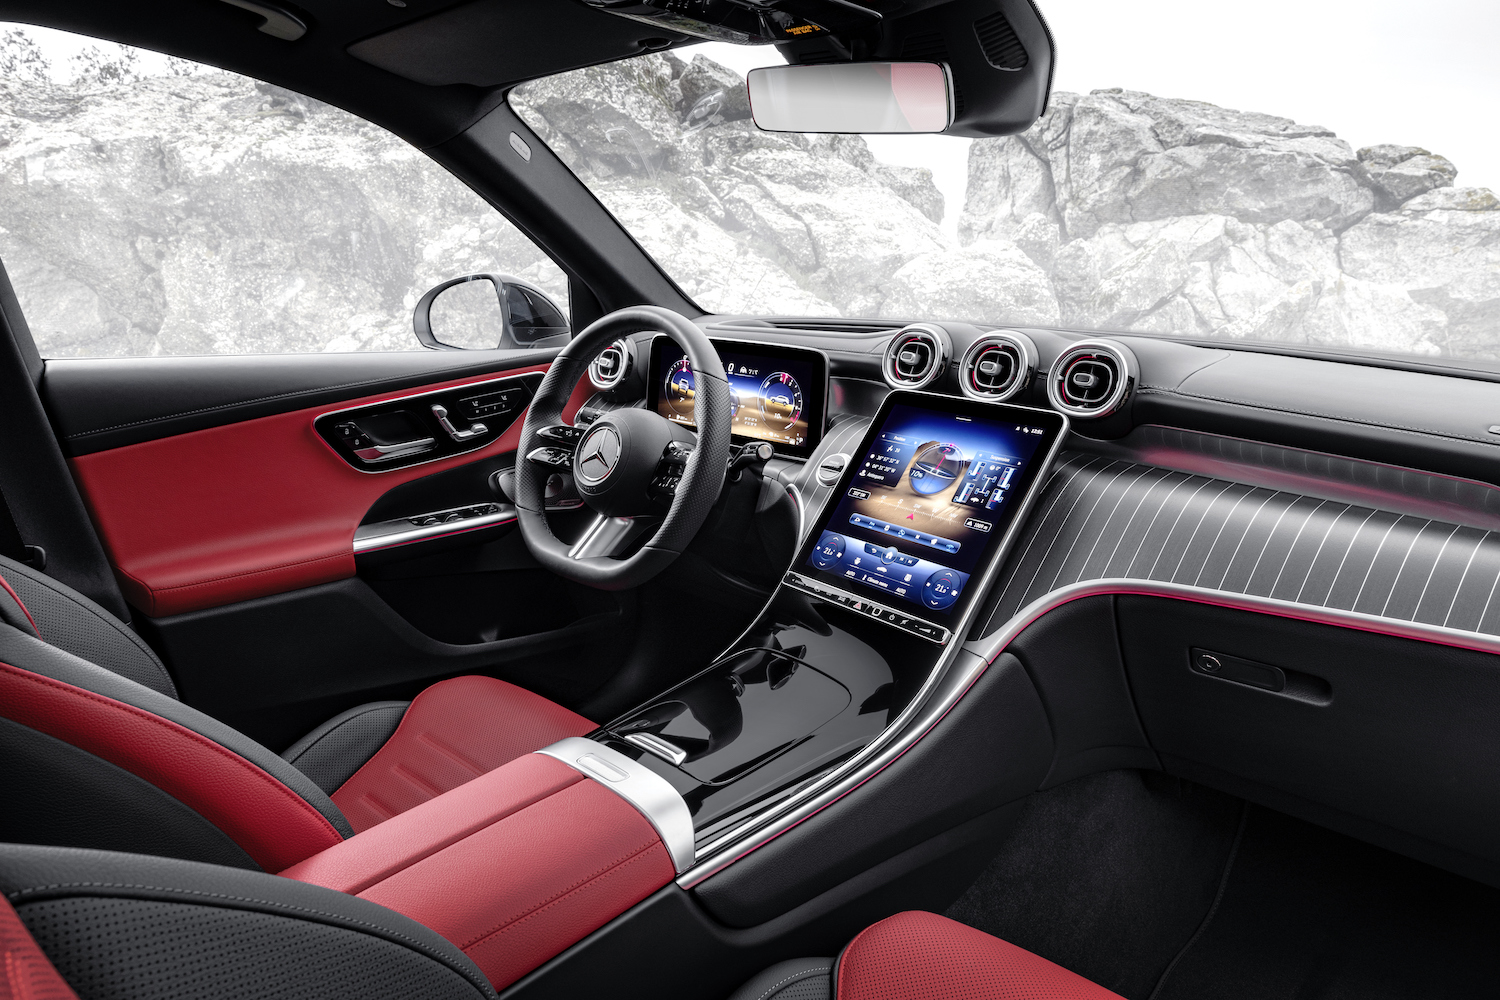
xmin=71 ymin=366 xmax=591 ymax=618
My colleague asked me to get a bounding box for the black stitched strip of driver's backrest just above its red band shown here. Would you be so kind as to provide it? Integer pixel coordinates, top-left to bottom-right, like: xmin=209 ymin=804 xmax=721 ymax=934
xmin=0 ymin=625 xmax=354 ymax=838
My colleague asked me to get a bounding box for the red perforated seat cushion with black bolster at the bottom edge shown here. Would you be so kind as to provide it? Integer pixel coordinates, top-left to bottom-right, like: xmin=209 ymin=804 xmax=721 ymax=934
xmin=731 ymin=910 xmax=1121 ymax=1000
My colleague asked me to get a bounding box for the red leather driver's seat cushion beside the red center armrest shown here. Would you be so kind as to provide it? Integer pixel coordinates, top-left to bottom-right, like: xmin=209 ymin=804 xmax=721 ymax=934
xmin=333 ymin=676 xmax=597 ymax=832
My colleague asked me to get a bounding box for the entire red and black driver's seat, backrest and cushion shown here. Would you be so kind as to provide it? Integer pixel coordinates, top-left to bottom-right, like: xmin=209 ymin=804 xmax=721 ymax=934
xmin=0 ymin=558 xmax=596 ymax=871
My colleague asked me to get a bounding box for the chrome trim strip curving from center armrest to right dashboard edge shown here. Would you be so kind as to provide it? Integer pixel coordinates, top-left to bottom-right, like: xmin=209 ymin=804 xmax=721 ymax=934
xmin=677 ymin=579 xmax=1500 ymax=889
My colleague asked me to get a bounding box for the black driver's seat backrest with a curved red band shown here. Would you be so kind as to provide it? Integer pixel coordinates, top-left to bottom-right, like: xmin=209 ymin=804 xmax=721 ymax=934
xmin=0 ymin=576 xmax=353 ymax=871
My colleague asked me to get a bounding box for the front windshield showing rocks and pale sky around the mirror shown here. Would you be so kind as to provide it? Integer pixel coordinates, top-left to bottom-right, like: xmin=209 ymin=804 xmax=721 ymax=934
xmin=512 ymin=0 xmax=1500 ymax=360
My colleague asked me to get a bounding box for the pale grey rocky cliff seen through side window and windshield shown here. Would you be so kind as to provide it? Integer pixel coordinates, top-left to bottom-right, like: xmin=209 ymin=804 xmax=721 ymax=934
xmin=0 ymin=54 xmax=1500 ymax=360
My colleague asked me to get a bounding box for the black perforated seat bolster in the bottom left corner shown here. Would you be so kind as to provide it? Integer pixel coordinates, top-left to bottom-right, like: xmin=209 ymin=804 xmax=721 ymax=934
xmin=0 ymin=844 xmax=495 ymax=1000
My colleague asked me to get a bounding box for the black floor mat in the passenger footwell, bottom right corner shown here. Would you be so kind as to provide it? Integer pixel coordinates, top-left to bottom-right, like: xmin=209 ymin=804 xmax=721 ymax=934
xmin=1155 ymin=808 xmax=1500 ymax=1000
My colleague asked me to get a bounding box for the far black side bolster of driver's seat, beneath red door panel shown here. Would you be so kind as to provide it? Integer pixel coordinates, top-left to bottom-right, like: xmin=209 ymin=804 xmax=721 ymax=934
xmin=0 ymin=556 xmax=177 ymax=697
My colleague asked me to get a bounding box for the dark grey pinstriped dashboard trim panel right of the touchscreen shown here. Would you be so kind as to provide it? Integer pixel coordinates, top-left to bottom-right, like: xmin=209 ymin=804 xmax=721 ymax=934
xmin=974 ymin=453 xmax=1500 ymax=636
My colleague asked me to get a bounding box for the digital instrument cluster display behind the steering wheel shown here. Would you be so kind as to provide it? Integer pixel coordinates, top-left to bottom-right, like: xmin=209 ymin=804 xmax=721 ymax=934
xmin=651 ymin=337 xmax=828 ymax=457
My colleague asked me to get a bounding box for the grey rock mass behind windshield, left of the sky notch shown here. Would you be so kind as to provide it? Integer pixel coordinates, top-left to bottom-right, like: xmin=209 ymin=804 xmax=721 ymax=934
xmin=512 ymin=54 xmax=953 ymax=315
